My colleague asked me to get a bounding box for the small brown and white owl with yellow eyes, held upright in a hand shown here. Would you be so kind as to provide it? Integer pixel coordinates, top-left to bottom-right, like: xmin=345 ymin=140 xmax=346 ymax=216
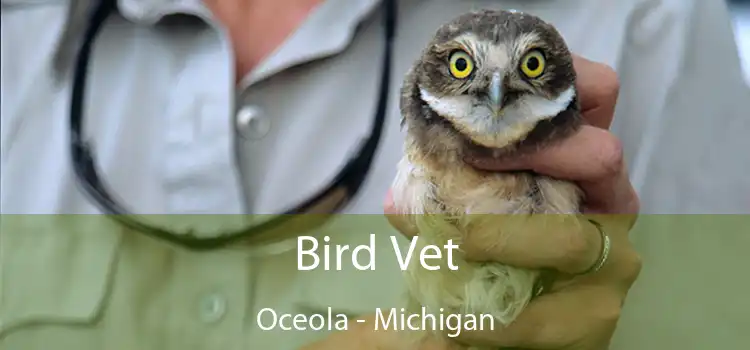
xmin=392 ymin=10 xmax=582 ymax=349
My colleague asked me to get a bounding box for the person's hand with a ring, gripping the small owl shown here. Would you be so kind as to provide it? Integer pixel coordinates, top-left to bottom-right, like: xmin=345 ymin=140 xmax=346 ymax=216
xmin=385 ymin=56 xmax=641 ymax=350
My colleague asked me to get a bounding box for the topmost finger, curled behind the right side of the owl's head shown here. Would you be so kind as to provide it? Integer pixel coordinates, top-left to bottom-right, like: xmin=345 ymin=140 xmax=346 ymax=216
xmin=573 ymin=55 xmax=620 ymax=129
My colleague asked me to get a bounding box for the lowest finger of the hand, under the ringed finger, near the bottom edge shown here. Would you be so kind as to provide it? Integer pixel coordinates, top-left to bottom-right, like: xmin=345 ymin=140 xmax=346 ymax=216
xmin=457 ymin=286 xmax=622 ymax=349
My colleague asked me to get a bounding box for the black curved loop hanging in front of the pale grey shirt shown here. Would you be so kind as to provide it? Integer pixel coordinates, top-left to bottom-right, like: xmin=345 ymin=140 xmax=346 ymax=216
xmin=70 ymin=0 xmax=396 ymax=250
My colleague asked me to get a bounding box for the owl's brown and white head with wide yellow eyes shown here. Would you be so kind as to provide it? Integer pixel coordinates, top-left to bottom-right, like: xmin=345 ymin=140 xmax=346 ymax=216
xmin=402 ymin=10 xmax=578 ymax=154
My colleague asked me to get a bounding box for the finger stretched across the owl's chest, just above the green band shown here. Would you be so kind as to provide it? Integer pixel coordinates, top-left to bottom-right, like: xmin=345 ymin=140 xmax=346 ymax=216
xmin=466 ymin=126 xmax=639 ymax=214
